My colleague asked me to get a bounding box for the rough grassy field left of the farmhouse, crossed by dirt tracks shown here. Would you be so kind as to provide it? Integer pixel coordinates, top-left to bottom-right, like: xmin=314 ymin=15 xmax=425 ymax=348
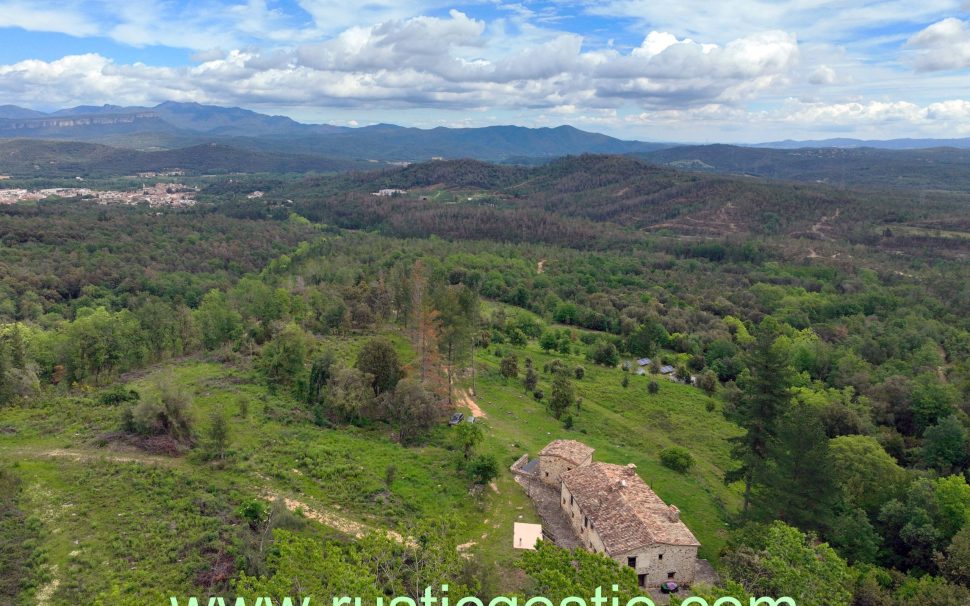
xmin=0 ymin=335 xmax=535 ymax=605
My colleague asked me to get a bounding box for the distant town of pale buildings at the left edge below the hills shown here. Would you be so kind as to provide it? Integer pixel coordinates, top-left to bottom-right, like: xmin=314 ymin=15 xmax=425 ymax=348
xmin=0 ymin=183 xmax=199 ymax=208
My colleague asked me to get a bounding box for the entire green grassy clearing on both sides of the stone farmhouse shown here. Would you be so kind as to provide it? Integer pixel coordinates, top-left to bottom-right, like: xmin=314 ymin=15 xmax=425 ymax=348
xmin=0 ymin=324 xmax=738 ymax=605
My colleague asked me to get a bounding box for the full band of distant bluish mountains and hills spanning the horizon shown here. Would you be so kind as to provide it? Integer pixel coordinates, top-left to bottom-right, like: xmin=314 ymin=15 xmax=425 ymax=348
xmin=0 ymin=102 xmax=970 ymax=185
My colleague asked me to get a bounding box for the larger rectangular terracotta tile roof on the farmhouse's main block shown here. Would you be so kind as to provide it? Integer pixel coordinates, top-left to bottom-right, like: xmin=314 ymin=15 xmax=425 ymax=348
xmin=562 ymin=463 xmax=700 ymax=555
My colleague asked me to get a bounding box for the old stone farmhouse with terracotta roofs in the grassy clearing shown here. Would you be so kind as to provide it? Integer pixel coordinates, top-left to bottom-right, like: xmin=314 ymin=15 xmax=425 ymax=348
xmin=512 ymin=440 xmax=700 ymax=587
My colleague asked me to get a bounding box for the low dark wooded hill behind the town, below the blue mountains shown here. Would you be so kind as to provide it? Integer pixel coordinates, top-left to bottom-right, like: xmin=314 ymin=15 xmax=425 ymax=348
xmin=0 ymin=139 xmax=364 ymax=178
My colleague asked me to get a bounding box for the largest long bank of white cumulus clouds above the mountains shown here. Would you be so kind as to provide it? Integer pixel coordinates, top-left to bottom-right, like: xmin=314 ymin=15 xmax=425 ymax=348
xmin=0 ymin=17 xmax=798 ymax=111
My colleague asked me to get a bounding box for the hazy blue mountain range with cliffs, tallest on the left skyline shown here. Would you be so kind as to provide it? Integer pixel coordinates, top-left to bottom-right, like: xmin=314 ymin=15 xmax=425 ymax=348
xmin=0 ymin=102 xmax=664 ymax=161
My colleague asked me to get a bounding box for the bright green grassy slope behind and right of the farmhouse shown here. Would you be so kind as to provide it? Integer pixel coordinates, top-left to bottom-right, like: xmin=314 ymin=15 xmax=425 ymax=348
xmin=462 ymin=343 xmax=740 ymax=559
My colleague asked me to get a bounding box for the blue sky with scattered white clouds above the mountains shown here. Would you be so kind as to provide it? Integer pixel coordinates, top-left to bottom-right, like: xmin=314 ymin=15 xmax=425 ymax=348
xmin=0 ymin=0 xmax=970 ymax=143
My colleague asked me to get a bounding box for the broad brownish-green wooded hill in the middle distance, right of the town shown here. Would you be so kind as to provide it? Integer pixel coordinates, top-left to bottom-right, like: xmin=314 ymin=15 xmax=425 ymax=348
xmin=270 ymin=155 xmax=970 ymax=256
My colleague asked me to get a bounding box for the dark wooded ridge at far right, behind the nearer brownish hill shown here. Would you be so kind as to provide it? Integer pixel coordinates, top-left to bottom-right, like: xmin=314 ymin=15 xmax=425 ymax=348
xmin=637 ymin=145 xmax=970 ymax=191
